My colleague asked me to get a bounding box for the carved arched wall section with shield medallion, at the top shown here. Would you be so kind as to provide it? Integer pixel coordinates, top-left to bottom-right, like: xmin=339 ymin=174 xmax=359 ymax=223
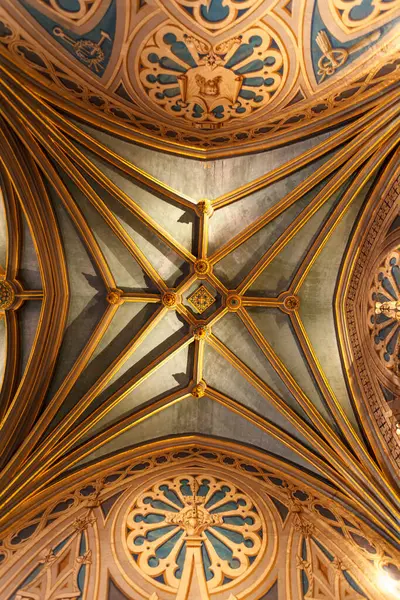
xmin=0 ymin=0 xmax=400 ymax=157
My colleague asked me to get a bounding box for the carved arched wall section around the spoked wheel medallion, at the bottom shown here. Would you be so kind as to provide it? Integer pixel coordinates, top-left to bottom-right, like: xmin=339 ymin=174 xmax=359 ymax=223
xmin=0 ymin=446 xmax=400 ymax=600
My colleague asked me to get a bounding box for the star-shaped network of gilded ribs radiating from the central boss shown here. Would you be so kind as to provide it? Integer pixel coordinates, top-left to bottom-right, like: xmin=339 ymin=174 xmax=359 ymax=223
xmin=0 ymin=49 xmax=400 ymax=564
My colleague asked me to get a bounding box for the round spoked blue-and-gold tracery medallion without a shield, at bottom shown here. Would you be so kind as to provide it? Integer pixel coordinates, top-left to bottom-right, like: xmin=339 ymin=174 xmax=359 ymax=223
xmin=126 ymin=474 xmax=267 ymax=592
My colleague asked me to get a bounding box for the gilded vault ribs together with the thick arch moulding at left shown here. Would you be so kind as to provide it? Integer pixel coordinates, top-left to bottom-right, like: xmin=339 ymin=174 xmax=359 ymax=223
xmin=0 ymin=54 xmax=400 ymax=556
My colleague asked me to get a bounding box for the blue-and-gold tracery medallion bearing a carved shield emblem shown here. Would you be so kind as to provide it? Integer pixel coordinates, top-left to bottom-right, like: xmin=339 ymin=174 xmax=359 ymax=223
xmin=139 ymin=24 xmax=287 ymax=129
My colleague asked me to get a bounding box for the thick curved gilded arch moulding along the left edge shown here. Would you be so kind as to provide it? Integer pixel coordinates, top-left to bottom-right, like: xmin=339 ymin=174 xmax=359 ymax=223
xmin=0 ymin=126 xmax=69 ymax=460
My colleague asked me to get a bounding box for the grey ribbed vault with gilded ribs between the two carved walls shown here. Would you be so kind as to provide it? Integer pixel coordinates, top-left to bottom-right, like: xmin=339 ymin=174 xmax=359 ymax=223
xmin=0 ymin=8 xmax=400 ymax=600
